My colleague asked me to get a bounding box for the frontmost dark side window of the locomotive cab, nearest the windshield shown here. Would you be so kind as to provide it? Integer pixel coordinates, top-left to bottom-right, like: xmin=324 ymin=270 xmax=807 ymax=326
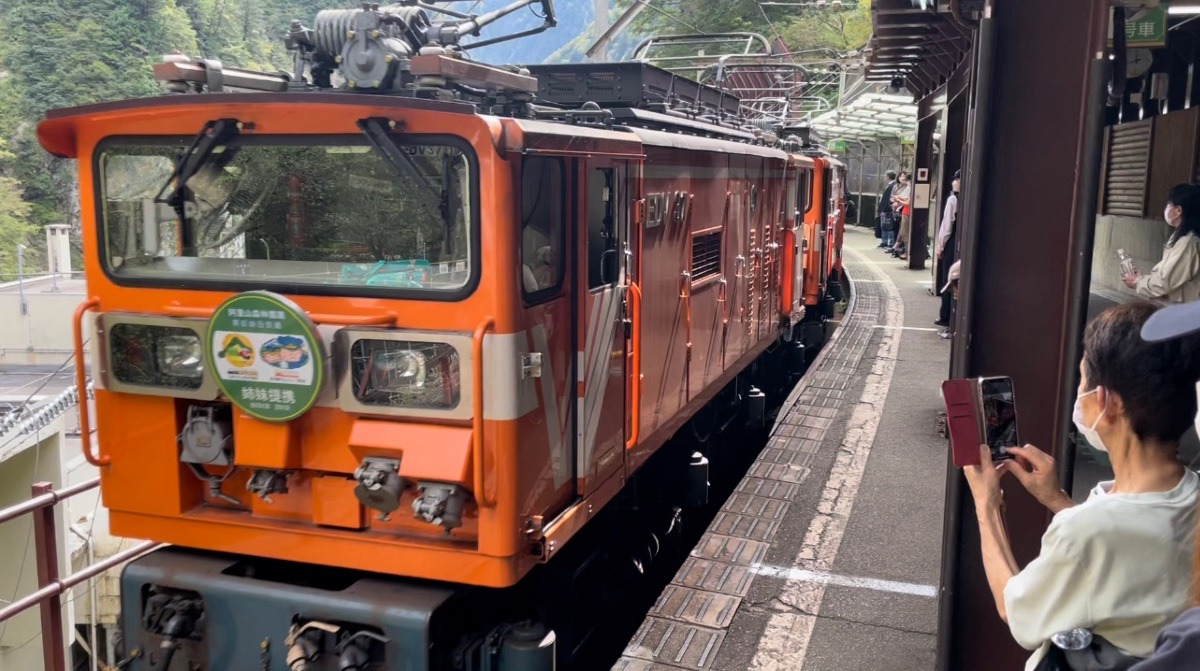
xmin=521 ymin=156 xmax=566 ymax=299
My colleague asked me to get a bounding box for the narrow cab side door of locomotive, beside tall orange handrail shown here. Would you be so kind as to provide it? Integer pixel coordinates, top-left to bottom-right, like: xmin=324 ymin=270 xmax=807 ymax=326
xmin=576 ymin=160 xmax=629 ymax=496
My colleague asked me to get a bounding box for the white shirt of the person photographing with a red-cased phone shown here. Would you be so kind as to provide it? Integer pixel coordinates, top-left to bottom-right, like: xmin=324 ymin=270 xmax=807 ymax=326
xmin=1004 ymin=471 xmax=1200 ymax=671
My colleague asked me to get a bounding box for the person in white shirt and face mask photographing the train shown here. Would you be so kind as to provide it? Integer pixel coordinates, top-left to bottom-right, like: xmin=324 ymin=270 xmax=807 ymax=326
xmin=964 ymin=301 xmax=1200 ymax=670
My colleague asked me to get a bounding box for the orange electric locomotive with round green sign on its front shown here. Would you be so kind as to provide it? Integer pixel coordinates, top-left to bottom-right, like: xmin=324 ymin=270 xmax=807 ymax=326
xmin=38 ymin=0 xmax=844 ymax=671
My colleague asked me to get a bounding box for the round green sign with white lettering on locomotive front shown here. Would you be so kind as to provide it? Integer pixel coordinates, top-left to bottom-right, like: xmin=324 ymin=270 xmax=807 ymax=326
xmin=206 ymin=292 xmax=325 ymax=421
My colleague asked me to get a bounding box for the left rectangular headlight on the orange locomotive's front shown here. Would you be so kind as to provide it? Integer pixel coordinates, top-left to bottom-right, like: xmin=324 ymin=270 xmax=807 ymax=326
xmin=109 ymin=324 xmax=204 ymax=390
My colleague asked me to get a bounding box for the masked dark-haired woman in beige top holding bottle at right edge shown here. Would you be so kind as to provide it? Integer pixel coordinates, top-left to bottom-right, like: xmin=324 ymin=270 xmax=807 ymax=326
xmin=1123 ymin=184 xmax=1200 ymax=302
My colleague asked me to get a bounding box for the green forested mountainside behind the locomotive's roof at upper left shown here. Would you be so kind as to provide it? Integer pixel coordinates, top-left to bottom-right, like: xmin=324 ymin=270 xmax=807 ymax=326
xmin=0 ymin=0 xmax=350 ymax=276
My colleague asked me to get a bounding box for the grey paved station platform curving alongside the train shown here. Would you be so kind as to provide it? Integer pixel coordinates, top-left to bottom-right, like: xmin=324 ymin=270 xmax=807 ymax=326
xmin=613 ymin=228 xmax=950 ymax=671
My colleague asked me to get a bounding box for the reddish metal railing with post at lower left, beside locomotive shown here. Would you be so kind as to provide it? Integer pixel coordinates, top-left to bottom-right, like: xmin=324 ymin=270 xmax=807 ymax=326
xmin=0 ymin=478 xmax=161 ymax=671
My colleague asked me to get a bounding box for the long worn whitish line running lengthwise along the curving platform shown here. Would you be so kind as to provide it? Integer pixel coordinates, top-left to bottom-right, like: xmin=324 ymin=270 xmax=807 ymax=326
xmin=750 ymin=248 xmax=904 ymax=671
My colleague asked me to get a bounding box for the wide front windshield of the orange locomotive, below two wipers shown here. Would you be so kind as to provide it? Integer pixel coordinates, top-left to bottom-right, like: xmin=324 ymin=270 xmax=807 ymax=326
xmin=96 ymin=136 xmax=478 ymax=294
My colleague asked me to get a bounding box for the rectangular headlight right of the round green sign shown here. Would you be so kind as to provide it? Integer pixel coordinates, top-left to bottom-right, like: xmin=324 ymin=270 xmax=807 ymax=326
xmin=350 ymin=340 xmax=461 ymax=409
